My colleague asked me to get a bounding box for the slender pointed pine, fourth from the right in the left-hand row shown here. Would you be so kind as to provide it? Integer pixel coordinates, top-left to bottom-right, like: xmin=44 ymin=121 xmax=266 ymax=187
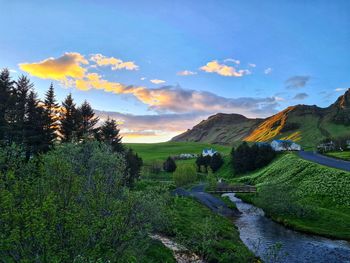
xmin=44 ymin=83 xmax=59 ymax=151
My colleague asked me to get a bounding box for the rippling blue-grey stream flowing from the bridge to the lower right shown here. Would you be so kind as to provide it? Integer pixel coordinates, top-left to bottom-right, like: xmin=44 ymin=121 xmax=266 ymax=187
xmin=224 ymin=194 xmax=350 ymax=263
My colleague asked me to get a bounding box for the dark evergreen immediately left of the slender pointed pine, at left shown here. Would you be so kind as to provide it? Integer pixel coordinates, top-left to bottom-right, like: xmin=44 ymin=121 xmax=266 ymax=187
xmin=24 ymin=91 xmax=46 ymax=160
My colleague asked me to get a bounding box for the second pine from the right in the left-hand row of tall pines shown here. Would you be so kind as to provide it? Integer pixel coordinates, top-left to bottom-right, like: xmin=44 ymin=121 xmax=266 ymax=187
xmin=78 ymin=101 xmax=99 ymax=139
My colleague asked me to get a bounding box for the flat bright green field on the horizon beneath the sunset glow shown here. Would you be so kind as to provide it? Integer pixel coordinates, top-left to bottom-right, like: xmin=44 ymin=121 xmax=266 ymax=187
xmin=126 ymin=142 xmax=231 ymax=163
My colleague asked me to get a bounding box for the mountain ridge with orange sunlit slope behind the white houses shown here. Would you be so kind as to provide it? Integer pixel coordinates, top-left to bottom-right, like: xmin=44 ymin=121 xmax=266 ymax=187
xmin=172 ymin=89 xmax=350 ymax=148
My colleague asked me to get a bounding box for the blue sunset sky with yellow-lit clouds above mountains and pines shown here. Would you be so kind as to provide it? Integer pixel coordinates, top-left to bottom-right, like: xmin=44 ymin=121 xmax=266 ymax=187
xmin=0 ymin=0 xmax=350 ymax=142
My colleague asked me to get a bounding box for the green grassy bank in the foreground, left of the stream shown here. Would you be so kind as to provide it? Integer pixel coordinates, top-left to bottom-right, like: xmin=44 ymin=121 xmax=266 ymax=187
xmin=164 ymin=197 xmax=255 ymax=262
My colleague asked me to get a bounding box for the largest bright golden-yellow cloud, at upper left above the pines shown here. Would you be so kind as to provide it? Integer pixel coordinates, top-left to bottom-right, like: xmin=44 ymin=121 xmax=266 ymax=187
xmin=19 ymin=52 xmax=89 ymax=81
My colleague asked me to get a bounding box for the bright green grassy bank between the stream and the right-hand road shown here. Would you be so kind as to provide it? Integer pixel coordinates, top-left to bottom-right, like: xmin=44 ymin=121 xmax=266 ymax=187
xmin=235 ymin=154 xmax=350 ymax=240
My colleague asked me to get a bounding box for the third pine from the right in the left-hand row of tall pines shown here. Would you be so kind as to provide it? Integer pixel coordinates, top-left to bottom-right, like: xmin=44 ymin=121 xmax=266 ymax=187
xmin=60 ymin=94 xmax=79 ymax=142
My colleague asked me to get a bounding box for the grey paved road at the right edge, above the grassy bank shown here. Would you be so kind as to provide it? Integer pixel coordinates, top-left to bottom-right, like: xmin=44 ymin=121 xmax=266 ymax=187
xmin=299 ymin=151 xmax=350 ymax=172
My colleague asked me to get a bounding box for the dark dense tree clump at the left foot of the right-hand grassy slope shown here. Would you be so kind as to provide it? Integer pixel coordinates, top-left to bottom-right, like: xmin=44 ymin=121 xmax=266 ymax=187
xmin=231 ymin=142 xmax=276 ymax=173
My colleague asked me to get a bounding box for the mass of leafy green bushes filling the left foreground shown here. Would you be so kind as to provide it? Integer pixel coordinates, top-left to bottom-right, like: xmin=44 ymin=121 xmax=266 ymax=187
xmin=0 ymin=143 xmax=165 ymax=262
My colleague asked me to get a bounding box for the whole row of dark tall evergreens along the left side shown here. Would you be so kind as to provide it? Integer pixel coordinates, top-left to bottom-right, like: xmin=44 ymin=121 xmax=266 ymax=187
xmin=0 ymin=69 xmax=142 ymax=184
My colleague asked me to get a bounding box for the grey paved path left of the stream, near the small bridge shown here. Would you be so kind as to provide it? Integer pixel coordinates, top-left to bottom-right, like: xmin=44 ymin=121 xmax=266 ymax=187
xmin=173 ymin=184 xmax=240 ymax=217
